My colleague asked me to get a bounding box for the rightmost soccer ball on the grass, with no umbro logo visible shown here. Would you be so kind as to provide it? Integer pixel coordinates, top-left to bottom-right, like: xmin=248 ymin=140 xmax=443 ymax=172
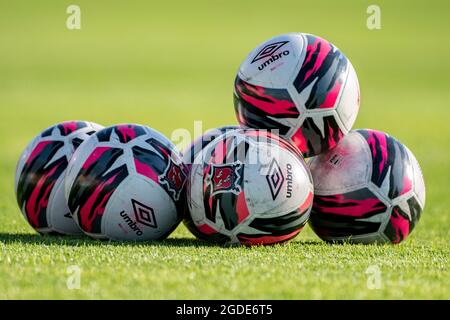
xmin=308 ymin=130 xmax=425 ymax=243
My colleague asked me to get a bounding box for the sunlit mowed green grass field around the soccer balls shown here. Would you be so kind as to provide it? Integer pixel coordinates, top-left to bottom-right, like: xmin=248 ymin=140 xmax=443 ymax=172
xmin=0 ymin=0 xmax=450 ymax=299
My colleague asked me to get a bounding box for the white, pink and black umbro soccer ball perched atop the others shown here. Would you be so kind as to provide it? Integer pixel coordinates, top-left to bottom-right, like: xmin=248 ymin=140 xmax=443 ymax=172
xmin=234 ymin=33 xmax=359 ymax=157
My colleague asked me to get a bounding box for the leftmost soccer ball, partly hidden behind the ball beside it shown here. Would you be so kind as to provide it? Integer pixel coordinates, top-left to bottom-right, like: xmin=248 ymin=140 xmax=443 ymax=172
xmin=15 ymin=121 xmax=103 ymax=235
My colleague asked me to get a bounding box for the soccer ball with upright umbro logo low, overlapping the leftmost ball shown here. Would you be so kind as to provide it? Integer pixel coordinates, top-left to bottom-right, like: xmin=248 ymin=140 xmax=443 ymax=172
xmin=66 ymin=124 xmax=187 ymax=240
